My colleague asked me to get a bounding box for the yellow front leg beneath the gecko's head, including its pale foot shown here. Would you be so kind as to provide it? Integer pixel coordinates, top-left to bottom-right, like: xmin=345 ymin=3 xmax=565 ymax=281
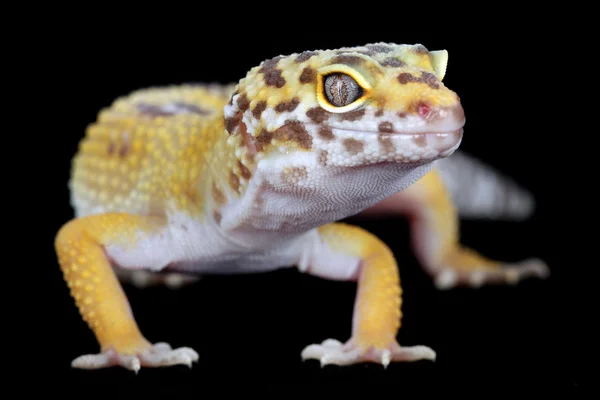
xmin=299 ymin=223 xmax=436 ymax=367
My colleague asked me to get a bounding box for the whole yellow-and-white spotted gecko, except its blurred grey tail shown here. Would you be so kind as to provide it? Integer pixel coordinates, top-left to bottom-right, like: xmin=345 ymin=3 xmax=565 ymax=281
xmin=55 ymin=43 xmax=546 ymax=371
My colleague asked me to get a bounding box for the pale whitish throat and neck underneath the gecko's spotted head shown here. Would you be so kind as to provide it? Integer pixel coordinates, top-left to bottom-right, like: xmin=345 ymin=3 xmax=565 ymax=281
xmin=221 ymin=153 xmax=433 ymax=242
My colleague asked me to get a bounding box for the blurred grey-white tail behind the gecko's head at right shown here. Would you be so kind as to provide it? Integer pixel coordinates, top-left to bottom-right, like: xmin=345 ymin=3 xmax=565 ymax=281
xmin=436 ymin=151 xmax=535 ymax=221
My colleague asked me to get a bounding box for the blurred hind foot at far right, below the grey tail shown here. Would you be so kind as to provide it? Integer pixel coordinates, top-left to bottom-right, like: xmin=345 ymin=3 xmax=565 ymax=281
xmin=435 ymin=258 xmax=550 ymax=290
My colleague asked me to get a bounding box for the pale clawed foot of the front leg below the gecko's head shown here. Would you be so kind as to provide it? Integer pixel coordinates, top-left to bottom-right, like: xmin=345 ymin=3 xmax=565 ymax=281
xmin=301 ymin=339 xmax=436 ymax=368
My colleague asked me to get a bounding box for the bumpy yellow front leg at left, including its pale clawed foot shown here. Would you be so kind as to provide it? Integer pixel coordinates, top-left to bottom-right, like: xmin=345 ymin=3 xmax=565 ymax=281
xmin=55 ymin=213 xmax=198 ymax=372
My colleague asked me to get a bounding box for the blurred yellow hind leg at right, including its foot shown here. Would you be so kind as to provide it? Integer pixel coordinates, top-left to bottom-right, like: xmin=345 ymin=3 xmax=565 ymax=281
xmin=365 ymin=170 xmax=550 ymax=289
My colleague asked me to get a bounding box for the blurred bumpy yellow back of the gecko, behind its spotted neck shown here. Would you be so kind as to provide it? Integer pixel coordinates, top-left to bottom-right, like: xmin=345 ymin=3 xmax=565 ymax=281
xmin=70 ymin=85 xmax=242 ymax=217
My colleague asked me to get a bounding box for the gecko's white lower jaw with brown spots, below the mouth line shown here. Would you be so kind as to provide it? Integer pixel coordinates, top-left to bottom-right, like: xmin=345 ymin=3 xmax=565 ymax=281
xmin=318 ymin=127 xmax=463 ymax=167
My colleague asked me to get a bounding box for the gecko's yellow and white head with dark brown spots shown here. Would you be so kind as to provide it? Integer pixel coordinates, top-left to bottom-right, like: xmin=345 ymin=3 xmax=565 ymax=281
xmin=225 ymin=43 xmax=465 ymax=167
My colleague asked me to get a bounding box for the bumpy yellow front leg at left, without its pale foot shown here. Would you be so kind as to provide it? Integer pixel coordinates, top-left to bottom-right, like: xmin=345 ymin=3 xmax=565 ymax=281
xmin=55 ymin=214 xmax=159 ymax=354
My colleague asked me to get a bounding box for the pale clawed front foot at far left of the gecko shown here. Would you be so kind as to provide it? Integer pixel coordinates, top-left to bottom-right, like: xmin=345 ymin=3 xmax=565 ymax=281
xmin=71 ymin=343 xmax=199 ymax=373
